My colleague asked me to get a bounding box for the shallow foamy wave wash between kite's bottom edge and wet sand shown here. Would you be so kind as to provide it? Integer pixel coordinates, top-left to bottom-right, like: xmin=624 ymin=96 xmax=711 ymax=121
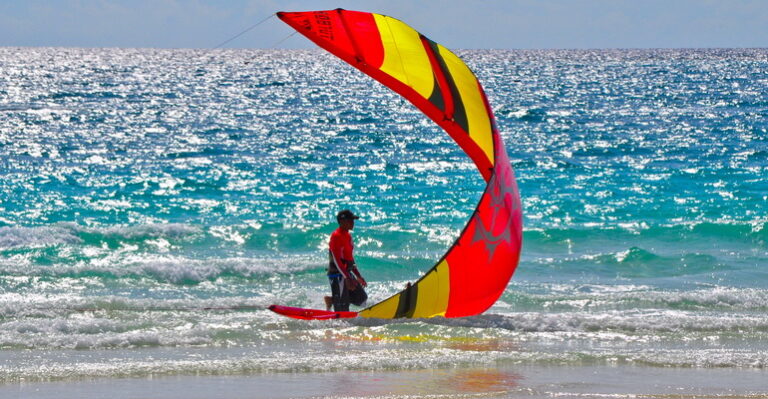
xmin=0 ymin=311 xmax=768 ymax=382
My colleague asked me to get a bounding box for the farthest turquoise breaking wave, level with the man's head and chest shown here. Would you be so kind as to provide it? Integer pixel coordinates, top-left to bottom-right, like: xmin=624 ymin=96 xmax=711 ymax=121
xmin=0 ymin=219 xmax=768 ymax=251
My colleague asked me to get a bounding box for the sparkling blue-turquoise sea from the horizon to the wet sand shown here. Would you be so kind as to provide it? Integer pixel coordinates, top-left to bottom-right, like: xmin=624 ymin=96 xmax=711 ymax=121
xmin=0 ymin=48 xmax=768 ymax=392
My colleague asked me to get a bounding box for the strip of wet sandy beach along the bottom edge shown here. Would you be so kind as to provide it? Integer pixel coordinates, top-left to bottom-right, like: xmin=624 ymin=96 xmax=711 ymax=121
xmin=0 ymin=365 xmax=768 ymax=399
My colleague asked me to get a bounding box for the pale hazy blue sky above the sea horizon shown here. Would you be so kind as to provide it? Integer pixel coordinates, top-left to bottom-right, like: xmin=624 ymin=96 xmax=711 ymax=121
xmin=0 ymin=0 xmax=768 ymax=49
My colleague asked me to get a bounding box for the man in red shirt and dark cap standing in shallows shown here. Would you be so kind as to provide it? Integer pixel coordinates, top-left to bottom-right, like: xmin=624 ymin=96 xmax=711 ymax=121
xmin=325 ymin=209 xmax=368 ymax=312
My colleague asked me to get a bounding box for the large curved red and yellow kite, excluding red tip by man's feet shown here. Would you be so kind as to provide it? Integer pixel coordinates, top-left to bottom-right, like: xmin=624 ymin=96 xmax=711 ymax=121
xmin=277 ymin=9 xmax=522 ymax=319
